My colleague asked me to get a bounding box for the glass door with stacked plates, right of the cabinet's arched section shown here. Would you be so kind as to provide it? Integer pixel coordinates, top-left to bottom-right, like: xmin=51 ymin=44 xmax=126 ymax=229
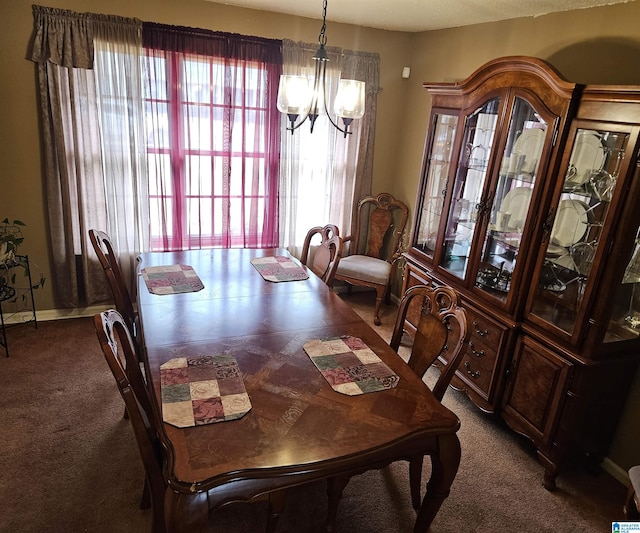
xmin=530 ymin=128 xmax=633 ymax=335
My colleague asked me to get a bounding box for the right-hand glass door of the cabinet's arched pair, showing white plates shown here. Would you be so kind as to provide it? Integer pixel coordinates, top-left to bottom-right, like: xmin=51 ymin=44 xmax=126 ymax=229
xmin=476 ymin=97 xmax=551 ymax=301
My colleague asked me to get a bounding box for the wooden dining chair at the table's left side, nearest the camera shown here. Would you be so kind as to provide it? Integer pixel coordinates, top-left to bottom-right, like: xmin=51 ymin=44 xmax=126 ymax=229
xmin=94 ymin=309 xmax=285 ymax=533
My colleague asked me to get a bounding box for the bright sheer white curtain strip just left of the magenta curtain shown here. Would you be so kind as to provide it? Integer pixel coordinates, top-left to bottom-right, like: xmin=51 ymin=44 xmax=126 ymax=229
xmin=94 ymin=19 xmax=149 ymax=296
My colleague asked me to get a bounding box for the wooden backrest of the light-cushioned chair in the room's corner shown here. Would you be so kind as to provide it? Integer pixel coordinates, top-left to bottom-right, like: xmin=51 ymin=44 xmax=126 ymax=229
xmin=349 ymin=193 xmax=409 ymax=262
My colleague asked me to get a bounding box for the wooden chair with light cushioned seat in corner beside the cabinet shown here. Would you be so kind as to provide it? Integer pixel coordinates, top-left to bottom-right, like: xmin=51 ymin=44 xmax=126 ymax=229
xmin=335 ymin=193 xmax=409 ymax=326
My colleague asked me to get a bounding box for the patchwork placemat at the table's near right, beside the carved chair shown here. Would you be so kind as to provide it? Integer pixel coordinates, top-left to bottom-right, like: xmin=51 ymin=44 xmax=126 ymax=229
xmin=303 ymin=336 xmax=400 ymax=396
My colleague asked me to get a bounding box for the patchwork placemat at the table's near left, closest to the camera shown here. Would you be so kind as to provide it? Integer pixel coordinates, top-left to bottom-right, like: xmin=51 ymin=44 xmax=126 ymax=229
xmin=160 ymin=354 xmax=251 ymax=428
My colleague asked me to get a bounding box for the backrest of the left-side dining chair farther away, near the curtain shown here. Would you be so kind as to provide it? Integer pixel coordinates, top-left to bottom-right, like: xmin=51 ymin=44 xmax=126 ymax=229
xmin=89 ymin=229 xmax=137 ymax=337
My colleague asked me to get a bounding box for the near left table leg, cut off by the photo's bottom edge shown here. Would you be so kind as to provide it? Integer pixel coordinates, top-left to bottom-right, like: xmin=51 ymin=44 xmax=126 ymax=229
xmin=164 ymin=488 xmax=209 ymax=533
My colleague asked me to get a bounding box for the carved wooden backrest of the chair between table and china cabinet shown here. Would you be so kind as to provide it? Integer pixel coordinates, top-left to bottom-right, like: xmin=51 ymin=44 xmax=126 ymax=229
xmin=390 ymin=285 xmax=470 ymax=400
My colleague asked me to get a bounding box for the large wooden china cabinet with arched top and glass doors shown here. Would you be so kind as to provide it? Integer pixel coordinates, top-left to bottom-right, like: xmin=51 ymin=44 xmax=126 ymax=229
xmin=403 ymin=57 xmax=640 ymax=489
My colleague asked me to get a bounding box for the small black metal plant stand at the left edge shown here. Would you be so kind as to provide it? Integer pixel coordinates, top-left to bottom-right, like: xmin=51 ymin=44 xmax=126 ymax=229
xmin=0 ymin=255 xmax=38 ymax=357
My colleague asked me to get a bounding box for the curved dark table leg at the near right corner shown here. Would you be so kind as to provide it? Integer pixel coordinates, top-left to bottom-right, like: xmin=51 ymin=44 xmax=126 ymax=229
xmin=413 ymin=433 xmax=460 ymax=533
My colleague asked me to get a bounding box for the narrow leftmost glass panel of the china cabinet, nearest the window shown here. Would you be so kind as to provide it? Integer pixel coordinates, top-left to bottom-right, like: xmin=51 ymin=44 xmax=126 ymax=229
xmin=413 ymin=113 xmax=458 ymax=257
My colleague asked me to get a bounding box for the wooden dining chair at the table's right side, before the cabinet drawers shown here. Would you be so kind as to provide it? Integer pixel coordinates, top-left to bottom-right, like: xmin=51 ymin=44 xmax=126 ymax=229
xmin=327 ymin=285 xmax=470 ymax=531
